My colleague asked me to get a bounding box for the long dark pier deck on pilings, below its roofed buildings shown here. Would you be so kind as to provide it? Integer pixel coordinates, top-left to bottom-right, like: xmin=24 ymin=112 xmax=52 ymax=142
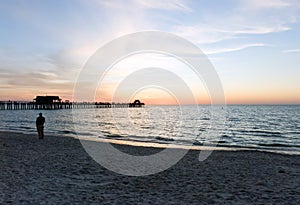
xmin=0 ymin=101 xmax=145 ymax=110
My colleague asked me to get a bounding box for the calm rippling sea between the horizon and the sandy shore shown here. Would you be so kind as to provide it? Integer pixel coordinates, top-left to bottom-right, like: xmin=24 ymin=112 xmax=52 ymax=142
xmin=0 ymin=105 xmax=300 ymax=154
